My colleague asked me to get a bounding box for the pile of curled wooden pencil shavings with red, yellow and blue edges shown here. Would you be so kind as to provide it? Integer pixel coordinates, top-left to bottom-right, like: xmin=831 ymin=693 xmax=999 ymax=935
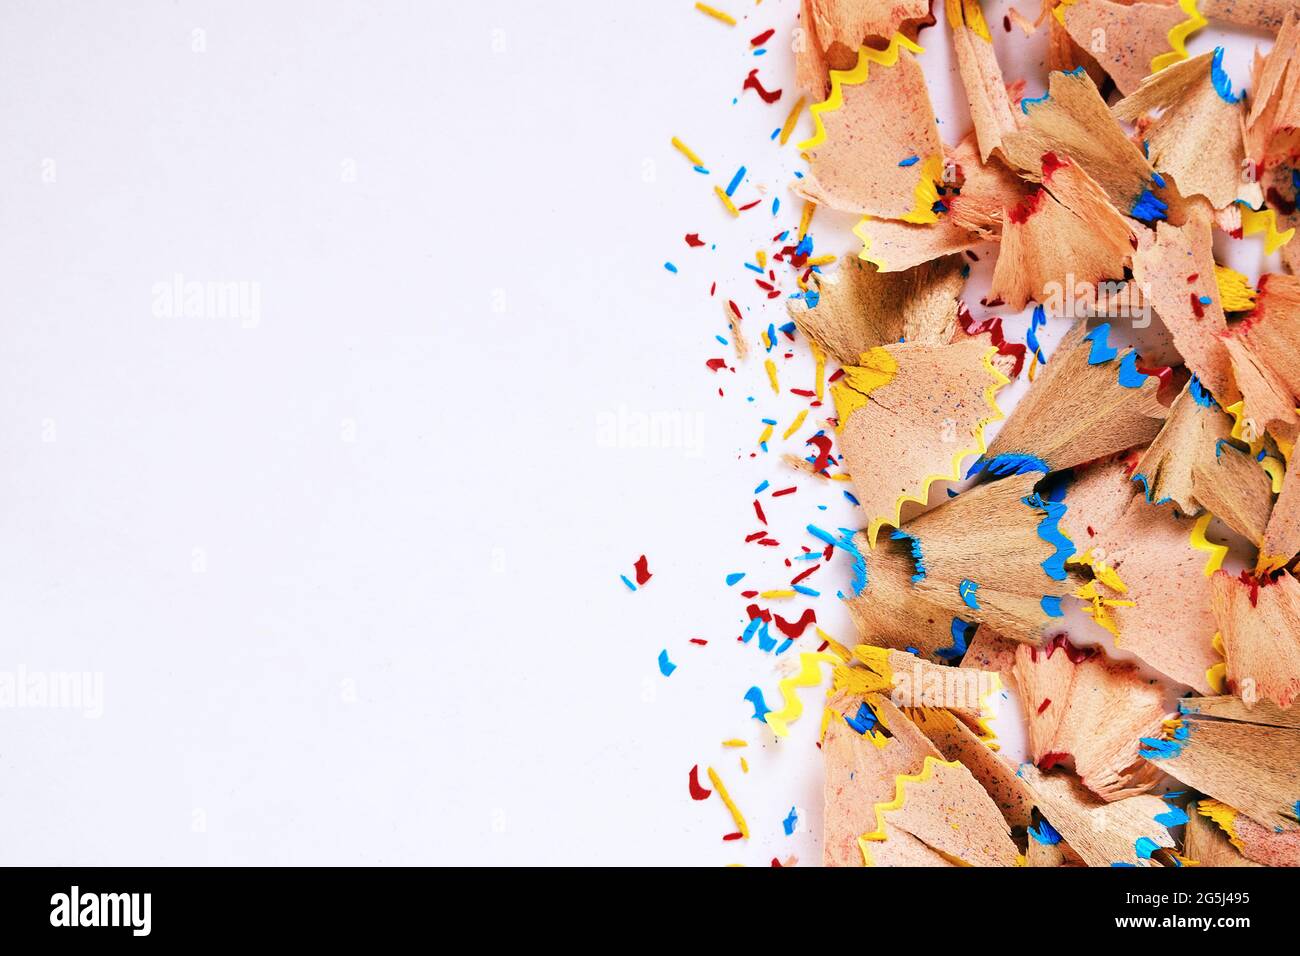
xmin=790 ymin=0 xmax=1300 ymax=866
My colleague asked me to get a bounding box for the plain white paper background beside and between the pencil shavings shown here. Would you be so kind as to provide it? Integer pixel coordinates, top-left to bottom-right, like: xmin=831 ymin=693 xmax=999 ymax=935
xmin=0 ymin=0 xmax=1274 ymax=865
